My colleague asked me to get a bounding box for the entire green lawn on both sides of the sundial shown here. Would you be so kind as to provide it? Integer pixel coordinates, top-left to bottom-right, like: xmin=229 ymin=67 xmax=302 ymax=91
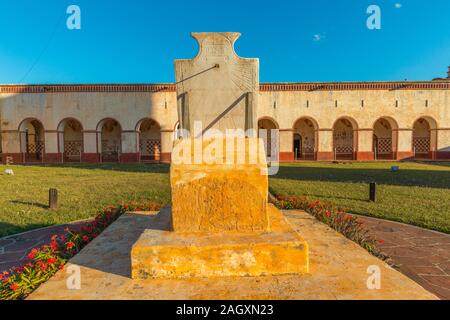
xmin=0 ymin=162 xmax=450 ymax=237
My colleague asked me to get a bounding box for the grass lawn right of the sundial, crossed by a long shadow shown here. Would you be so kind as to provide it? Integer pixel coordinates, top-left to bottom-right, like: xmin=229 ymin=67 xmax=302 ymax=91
xmin=270 ymin=162 xmax=450 ymax=233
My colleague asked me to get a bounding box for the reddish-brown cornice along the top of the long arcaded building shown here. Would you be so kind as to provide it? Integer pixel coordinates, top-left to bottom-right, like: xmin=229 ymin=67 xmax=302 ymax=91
xmin=0 ymin=81 xmax=450 ymax=93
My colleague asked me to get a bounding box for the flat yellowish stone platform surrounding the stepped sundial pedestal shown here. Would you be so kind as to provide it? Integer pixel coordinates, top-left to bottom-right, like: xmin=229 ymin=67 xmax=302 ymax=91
xmin=29 ymin=211 xmax=437 ymax=300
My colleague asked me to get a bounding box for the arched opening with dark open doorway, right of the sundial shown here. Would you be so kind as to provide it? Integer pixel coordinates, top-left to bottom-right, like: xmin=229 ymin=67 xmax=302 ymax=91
xmin=293 ymin=118 xmax=319 ymax=160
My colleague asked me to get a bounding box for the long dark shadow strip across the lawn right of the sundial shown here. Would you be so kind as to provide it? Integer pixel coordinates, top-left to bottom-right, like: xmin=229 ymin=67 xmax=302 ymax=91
xmin=272 ymin=166 xmax=450 ymax=189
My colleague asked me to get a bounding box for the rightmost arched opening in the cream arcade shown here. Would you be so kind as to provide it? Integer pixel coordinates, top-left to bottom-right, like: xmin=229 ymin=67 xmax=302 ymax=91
xmin=413 ymin=117 xmax=437 ymax=159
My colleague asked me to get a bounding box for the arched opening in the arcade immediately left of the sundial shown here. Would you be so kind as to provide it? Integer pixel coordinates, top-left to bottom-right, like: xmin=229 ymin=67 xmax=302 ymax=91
xmin=137 ymin=119 xmax=161 ymax=162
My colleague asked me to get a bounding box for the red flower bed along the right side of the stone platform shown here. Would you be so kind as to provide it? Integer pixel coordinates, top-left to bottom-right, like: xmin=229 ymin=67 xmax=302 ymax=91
xmin=273 ymin=195 xmax=387 ymax=260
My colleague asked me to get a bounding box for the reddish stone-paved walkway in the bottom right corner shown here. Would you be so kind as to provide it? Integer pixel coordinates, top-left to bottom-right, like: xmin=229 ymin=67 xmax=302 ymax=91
xmin=359 ymin=217 xmax=450 ymax=300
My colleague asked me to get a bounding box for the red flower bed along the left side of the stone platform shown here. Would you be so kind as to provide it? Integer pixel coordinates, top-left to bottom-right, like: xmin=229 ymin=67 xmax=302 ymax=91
xmin=0 ymin=202 xmax=160 ymax=300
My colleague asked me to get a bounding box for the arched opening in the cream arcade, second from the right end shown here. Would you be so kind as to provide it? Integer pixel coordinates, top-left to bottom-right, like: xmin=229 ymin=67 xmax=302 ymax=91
xmin=373 ymin=118 xmax=398 ymax=160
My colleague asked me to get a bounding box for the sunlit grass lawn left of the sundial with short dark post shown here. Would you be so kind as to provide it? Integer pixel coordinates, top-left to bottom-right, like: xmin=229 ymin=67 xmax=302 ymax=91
xmin=0 ymin=164 xmax=170 ymax=237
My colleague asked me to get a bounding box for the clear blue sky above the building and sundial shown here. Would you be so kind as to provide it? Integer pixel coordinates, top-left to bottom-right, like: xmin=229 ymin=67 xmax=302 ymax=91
xmin=0 ymin=0 xmax=450 ymax=83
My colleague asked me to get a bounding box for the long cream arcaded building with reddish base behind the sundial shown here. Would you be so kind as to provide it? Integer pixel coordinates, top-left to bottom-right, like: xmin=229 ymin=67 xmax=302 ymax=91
xmin=0 ymin=64 xmax=450 ymax=164
